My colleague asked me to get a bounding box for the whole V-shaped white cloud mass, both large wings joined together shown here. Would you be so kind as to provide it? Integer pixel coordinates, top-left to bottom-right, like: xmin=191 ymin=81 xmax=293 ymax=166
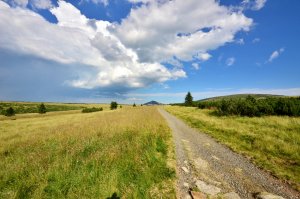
xmin=0 ymin=0 xmax=252 ymax=89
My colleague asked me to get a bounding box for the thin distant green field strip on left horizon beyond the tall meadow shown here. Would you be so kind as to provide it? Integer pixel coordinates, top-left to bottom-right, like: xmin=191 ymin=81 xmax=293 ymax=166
xmin=0 ymin=102 xmax=109 ymax=115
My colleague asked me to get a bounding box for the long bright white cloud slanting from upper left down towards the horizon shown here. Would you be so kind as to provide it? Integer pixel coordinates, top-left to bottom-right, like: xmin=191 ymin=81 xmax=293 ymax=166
xmin=0 ymin=1 xmax=185 ymax=89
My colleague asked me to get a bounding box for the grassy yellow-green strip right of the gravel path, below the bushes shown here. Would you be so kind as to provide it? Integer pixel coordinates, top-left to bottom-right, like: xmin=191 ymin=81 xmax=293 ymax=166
xmin=165 ymin=106 xmax=300 ymax=190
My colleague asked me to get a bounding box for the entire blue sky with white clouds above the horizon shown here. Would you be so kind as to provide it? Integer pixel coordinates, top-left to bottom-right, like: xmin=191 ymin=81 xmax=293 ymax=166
xmin=0 ymin=0 xmax=300 ymax=103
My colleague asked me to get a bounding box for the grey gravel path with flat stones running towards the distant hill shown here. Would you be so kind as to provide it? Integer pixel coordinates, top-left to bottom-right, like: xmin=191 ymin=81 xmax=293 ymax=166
xmin=159 ymin=109 xmax=300 ymax=199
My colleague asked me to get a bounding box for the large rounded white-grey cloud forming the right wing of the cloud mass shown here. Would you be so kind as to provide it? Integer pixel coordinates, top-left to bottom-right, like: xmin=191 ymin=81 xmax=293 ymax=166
xmin=112 ymin=0 xmax=252 ymax=62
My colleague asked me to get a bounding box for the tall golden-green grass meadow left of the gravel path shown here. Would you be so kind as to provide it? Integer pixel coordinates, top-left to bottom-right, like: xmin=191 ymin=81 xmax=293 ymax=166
xmin=0 ymin=107 xmax=175 ymax=198
